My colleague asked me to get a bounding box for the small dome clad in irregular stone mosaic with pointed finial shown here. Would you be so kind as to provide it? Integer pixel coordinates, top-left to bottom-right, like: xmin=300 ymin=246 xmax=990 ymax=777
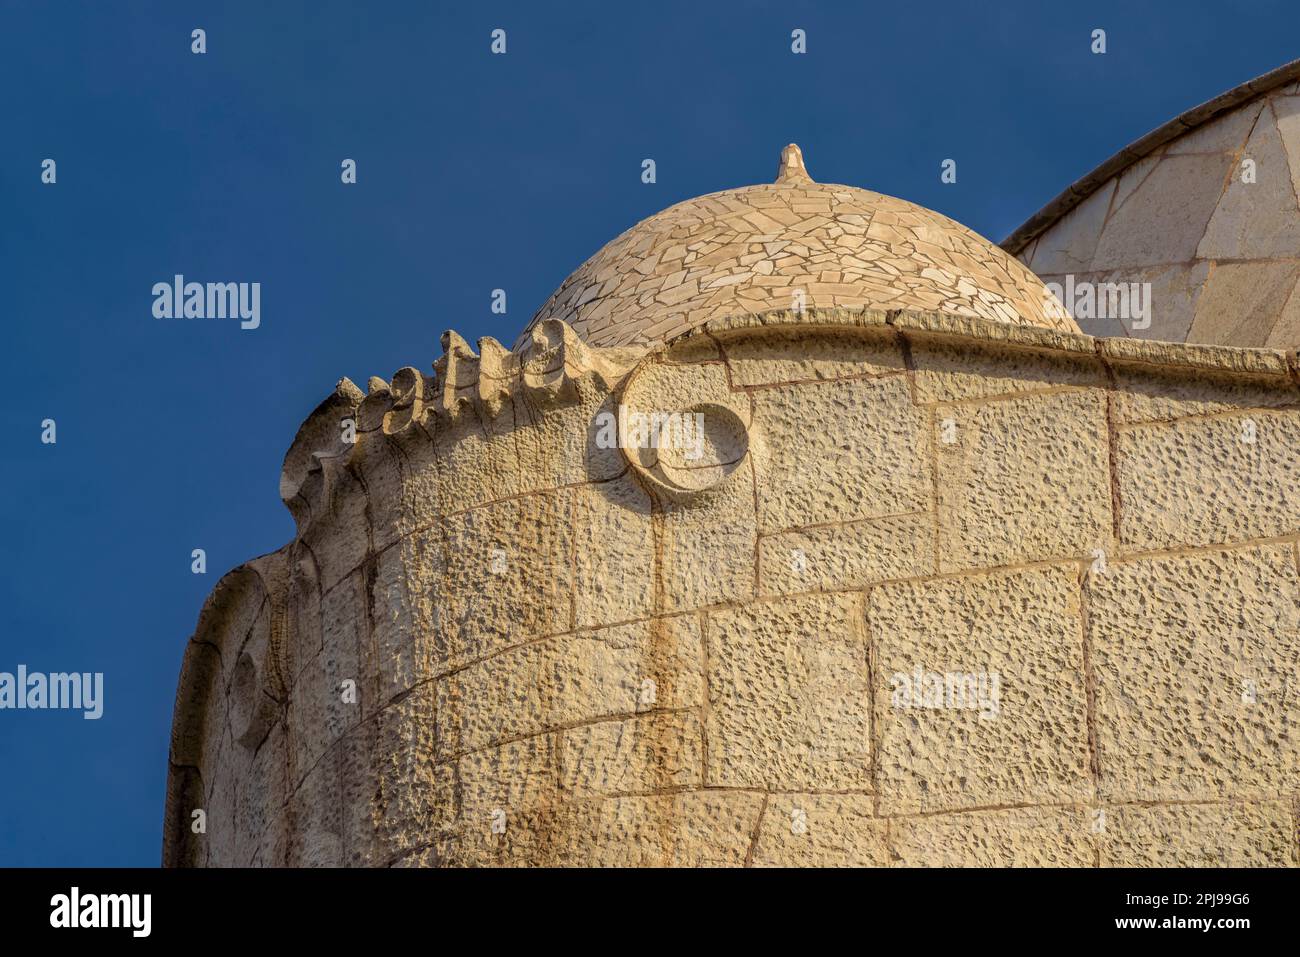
xmin=517 ymin=144 xmax=1078 ymax=346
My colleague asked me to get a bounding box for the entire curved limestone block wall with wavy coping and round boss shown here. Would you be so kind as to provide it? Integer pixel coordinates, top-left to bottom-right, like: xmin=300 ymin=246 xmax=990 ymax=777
xmin=164 ymin=311 xmax=1300 ymax=866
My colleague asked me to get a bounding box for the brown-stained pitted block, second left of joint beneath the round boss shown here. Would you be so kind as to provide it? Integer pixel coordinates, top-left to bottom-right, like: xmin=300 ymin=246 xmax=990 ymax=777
xmin=438 ymin=492 xmax=573 ymax=664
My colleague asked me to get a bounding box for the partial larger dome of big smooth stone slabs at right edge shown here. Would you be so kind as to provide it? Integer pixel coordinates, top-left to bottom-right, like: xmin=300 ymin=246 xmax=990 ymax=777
xmin=1002 ymin=60 xmax=1300 ymax=350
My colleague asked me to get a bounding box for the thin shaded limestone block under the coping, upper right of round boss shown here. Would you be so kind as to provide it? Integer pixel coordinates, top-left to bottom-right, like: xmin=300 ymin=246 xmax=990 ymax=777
xmin=722 ymin=325 xmax=904 ymax=389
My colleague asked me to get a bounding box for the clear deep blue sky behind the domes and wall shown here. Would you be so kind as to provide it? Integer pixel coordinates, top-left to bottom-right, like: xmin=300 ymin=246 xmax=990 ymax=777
xmin=0 ymin=0 xmax=1300 ymax=866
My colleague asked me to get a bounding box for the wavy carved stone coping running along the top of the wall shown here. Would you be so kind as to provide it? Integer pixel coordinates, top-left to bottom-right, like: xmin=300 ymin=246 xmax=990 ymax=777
xmin=281 ymin=308 xmax=1300 ymax=540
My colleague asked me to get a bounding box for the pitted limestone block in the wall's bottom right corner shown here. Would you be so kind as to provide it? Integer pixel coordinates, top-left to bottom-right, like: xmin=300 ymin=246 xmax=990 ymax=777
xmin=1096 ymin=801 xmax=1296 ymax=867
